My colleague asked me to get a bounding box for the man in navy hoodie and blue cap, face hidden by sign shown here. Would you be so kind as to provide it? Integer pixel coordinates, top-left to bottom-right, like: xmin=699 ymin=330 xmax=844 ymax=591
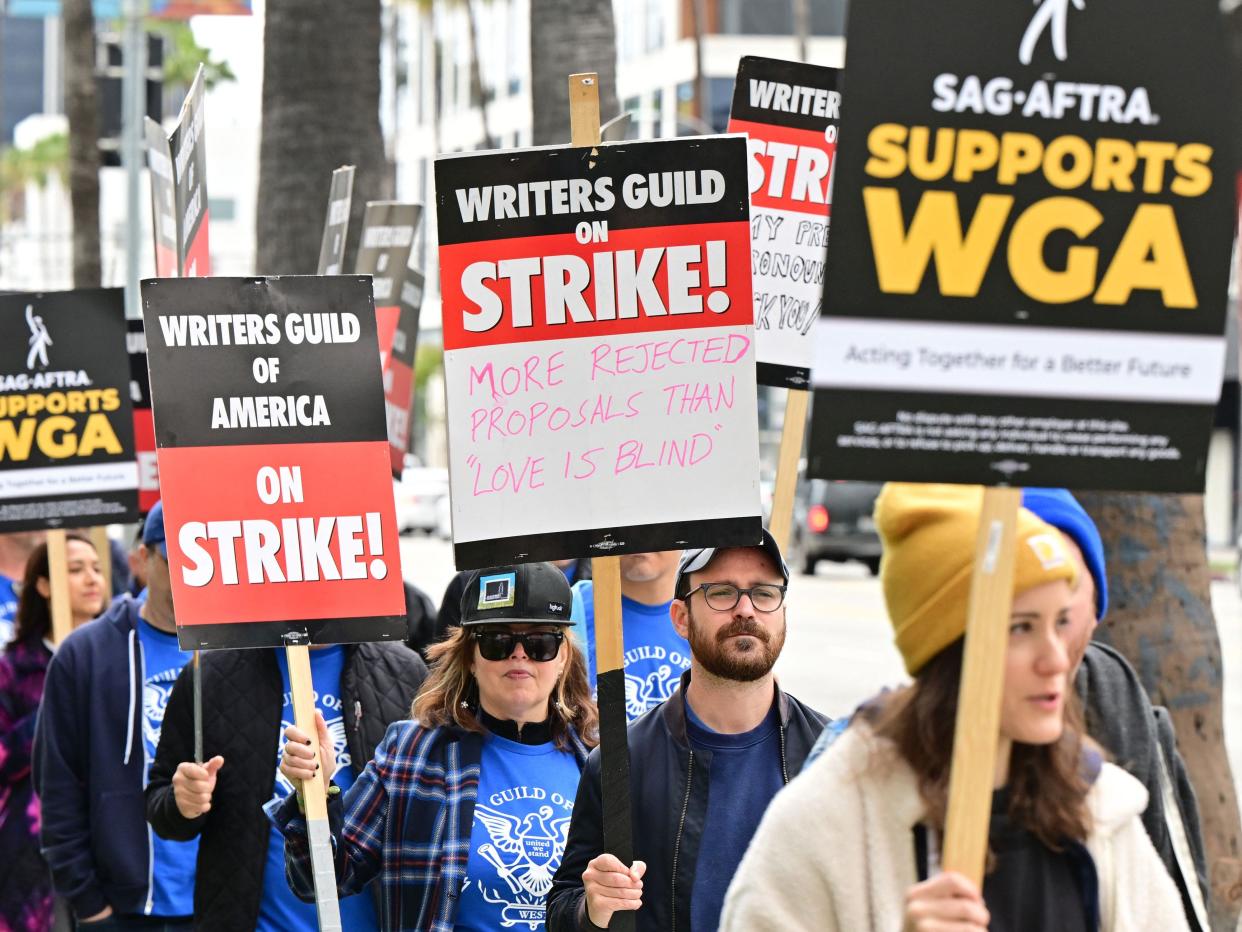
xmin=32 ymin=503 xmax=197 ymax=930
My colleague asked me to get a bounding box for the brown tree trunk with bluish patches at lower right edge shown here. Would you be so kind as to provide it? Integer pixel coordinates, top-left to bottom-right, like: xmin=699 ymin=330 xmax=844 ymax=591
xmin=1077 ymin=492 xmax=1242 ymax=932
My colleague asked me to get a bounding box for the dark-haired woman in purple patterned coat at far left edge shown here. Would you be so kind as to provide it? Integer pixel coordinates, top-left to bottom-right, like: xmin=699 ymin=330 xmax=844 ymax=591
xmin=0 ymin=534 xmax=104 ymax=930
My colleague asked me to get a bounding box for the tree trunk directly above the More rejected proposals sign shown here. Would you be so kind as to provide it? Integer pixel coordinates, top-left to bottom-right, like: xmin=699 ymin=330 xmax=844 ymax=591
xmin=530 ymin=0 xmax=621 ymax=145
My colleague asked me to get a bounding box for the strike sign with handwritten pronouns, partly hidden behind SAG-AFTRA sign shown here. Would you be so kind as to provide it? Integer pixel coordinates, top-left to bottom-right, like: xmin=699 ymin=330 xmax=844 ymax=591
xmin=729 ymin=56 xmax=841 ymax=389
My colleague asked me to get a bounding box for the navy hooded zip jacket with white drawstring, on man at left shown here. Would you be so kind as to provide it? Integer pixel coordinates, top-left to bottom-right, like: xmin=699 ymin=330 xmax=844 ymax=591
xmin=32 ymin=596 xmax=170 ymax=918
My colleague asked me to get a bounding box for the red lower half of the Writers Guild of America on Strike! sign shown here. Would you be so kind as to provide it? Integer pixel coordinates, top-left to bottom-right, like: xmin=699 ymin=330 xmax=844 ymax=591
xmin=159 ymin=441 xmax=405 ymax=626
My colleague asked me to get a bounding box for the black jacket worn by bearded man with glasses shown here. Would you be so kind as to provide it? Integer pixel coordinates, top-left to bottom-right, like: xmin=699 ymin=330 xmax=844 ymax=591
xmin=546 ymin=671 xmax=827 ymax=932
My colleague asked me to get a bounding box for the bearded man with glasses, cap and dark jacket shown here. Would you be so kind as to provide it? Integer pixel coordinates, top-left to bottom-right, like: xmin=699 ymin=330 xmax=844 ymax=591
xmin=546 ymin=532 xmax=826 ymax=932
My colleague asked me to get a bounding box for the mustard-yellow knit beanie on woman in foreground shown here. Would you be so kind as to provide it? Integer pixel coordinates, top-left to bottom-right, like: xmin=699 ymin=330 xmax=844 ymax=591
xmin=876 ymin=482 xmax=1077 ymax=676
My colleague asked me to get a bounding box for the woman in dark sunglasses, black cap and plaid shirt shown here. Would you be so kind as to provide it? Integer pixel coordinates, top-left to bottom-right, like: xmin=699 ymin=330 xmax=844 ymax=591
xmin=268 ymin=563 xmax=599 ymax=932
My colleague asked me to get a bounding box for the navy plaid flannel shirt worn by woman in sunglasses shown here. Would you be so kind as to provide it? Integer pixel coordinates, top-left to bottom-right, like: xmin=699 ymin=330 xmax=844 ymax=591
xmin=267 ymin=721 xmax=587 ymax=932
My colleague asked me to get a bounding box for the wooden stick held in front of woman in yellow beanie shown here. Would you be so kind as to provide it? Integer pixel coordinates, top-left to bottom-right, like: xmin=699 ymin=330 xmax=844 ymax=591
xmin=941 ymin=488 xmax=1022 ymax=889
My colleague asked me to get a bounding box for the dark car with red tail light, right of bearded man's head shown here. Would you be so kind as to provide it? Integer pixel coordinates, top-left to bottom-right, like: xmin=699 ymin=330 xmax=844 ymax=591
xmin=790 ymin=478 xmax=881 ymax=575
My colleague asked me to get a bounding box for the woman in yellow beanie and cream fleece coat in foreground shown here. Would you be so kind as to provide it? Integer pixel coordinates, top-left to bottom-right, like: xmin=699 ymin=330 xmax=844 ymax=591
xmin=720 ymin=483 xmax=1186 ymax=932
